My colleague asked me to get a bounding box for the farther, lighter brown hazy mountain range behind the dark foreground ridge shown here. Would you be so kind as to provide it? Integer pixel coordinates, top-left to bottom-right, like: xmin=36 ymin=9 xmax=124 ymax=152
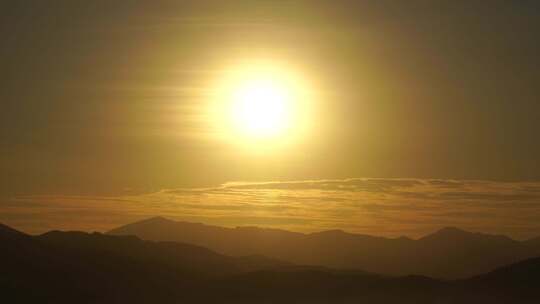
xmin=108 ymin=217 xmax=540 ymax=279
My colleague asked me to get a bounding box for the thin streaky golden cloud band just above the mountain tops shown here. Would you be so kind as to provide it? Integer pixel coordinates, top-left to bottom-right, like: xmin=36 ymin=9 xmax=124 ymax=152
xmin=0 ymin=178 xmax=540 ymax=239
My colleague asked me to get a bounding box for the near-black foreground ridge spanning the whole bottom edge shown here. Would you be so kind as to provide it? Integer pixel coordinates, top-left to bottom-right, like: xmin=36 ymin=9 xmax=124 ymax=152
xmin=0 ymin=225 xmax=540 ymax=304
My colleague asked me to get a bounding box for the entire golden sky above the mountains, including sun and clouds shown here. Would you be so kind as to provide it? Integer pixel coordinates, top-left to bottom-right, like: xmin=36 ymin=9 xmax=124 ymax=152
xmin=0 ymin=0 xmax=540 ymax=237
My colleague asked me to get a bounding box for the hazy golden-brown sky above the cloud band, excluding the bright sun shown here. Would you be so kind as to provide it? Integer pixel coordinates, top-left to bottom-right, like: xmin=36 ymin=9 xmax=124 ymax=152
xmin=0 ymin=0 xmax=540 ymax=235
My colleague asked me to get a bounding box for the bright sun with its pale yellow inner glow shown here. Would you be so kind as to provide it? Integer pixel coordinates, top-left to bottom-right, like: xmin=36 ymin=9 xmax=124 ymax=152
xmin=213 ymin=62 xmax=310 ymax=146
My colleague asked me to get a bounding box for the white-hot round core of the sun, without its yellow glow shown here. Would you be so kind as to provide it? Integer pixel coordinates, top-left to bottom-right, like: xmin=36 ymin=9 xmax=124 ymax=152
xmin=229 ymin=75 xmax=294 ymax=138
